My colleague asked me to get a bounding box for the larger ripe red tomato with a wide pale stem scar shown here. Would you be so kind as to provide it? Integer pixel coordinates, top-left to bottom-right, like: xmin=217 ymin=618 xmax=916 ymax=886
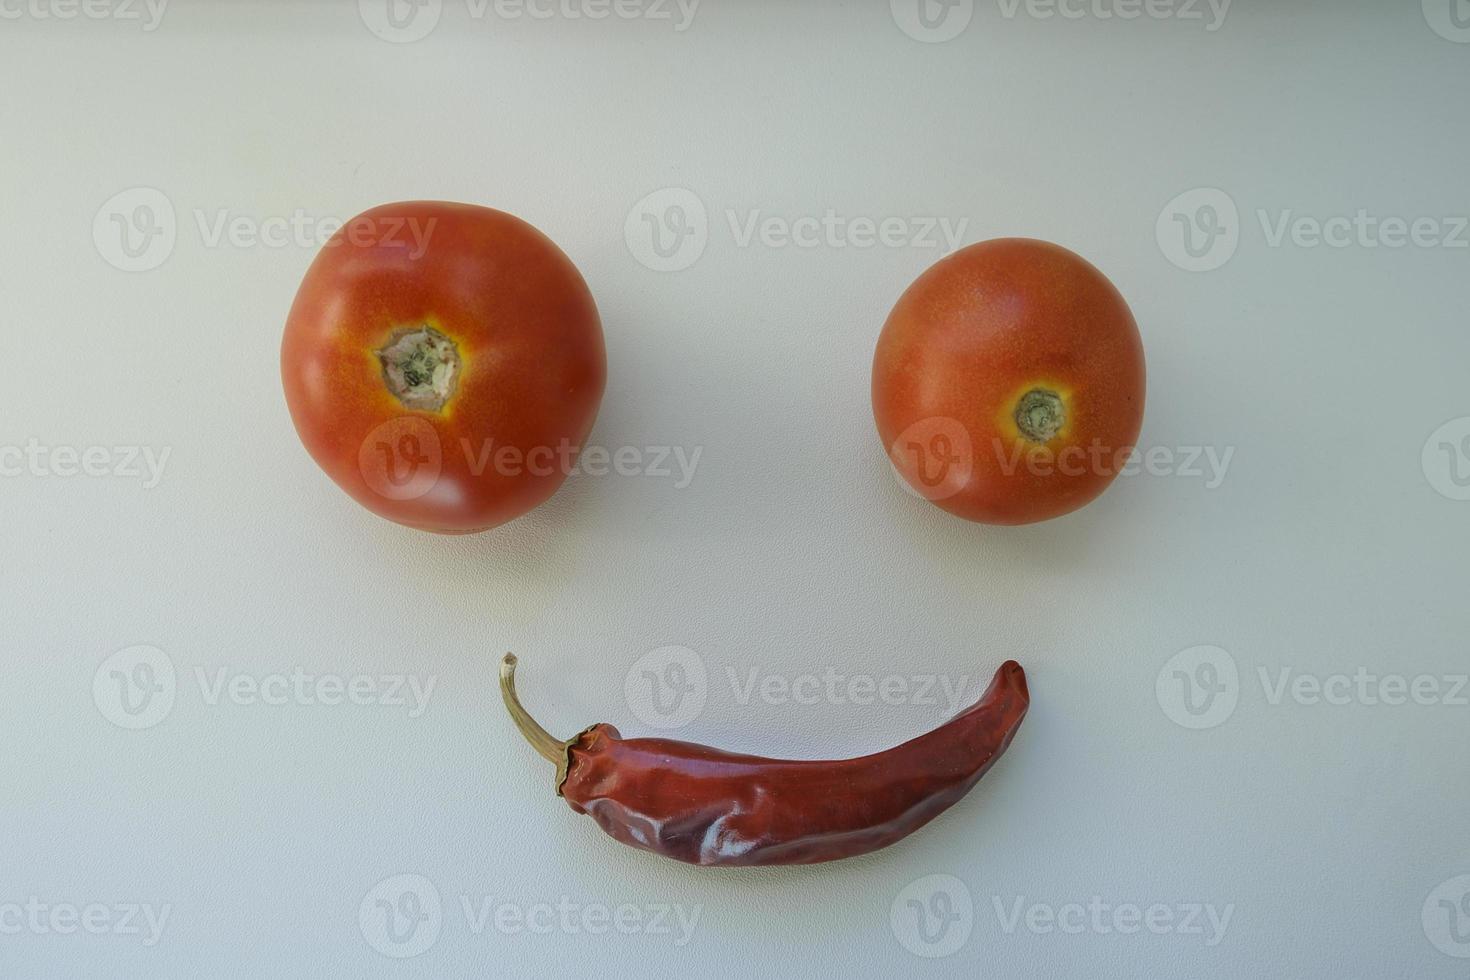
xmin=281 ymin=201 xmax=607 ymax=533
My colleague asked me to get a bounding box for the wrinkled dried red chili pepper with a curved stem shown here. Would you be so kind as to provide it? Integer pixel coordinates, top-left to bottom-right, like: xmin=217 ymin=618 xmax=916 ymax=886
xmin=500 ymin=654 xmax=1030 ymax=864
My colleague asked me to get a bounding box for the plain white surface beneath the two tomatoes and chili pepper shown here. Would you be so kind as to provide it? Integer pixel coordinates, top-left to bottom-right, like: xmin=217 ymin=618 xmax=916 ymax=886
xmin=0 ymin=0 xmax=1470 ymax=977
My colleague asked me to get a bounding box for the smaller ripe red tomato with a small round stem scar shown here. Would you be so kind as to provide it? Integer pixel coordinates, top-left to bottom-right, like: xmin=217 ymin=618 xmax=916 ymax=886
xmin=873 ymin=238 xmax=1144 ymax=525
